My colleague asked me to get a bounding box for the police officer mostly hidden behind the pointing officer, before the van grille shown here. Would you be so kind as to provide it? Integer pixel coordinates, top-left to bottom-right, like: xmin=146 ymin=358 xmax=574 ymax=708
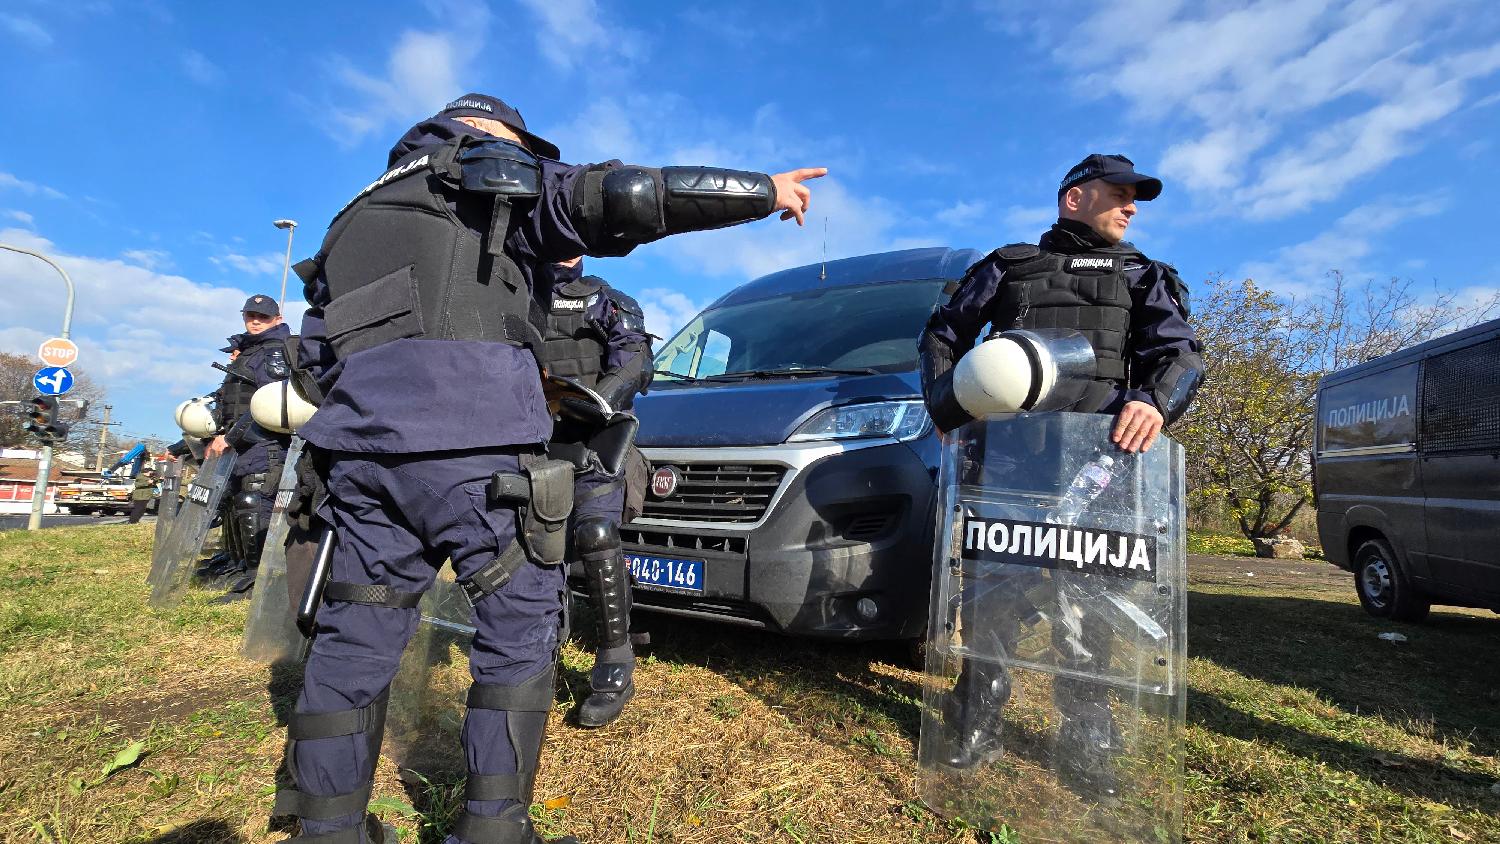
xmin=537 ymin=259 xmax=653 ymax=727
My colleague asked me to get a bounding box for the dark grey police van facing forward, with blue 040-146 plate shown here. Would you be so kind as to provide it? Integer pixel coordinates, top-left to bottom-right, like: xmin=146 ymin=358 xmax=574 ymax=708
xmin=597 ymin=247 xmax=983 ymax=639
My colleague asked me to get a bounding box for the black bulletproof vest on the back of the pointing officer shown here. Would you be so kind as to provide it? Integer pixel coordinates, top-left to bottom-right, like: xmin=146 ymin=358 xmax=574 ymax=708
xmin=309 ymin=136 xmax=542 ymax=360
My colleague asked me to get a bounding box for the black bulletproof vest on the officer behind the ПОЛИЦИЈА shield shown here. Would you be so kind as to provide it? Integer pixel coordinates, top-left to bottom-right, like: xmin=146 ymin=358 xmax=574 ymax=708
xmin=990 ymin=244 xmax=1140 ymax=387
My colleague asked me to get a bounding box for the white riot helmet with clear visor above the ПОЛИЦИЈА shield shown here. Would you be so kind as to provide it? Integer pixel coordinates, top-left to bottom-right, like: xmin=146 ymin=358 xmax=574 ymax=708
xmin=953 ymin=328 xmax=1095 ymax=418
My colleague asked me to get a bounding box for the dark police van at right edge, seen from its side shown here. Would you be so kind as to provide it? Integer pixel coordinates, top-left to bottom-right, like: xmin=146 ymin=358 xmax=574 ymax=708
xmin=1313 ymin=319 xmax=1500 ymax=621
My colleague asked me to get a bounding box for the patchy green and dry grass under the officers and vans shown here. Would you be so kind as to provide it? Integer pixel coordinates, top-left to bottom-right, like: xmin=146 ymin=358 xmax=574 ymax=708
xmin=0 ymin=525 xmax=1500 ymax=844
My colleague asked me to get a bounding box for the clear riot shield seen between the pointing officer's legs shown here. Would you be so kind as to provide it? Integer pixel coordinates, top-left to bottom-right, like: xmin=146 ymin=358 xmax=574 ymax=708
xmin=383 ymin=567 xmax=474 ymax=783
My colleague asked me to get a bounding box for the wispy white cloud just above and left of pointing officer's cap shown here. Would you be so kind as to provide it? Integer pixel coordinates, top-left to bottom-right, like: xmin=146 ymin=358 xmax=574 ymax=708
xmin=326 ymin=0 xmax=489 ymax=145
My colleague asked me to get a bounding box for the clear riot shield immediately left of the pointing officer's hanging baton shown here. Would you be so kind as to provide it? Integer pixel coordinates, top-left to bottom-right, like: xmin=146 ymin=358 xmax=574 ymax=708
xmin=240 ymin=436 xmax=303 ymax=663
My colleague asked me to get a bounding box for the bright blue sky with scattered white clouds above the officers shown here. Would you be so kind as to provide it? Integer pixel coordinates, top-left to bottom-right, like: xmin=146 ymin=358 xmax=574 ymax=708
xmin=0 ymin=0 xmax=1500 ymax=436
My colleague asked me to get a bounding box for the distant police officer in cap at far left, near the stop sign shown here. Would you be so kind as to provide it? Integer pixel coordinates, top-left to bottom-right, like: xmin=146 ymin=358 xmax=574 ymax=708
xmin=206 ymin=294 xmax=293 ymax=603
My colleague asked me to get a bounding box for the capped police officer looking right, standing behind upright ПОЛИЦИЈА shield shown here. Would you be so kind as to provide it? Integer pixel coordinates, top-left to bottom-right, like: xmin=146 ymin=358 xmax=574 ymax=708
xmin=920 ymin=154 xmax=1205 ymax=795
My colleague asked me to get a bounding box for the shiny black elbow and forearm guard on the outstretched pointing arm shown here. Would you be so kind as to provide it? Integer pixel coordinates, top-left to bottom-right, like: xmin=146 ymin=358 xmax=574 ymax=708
xmin=600 ymin=166 xmax=776 ymax=243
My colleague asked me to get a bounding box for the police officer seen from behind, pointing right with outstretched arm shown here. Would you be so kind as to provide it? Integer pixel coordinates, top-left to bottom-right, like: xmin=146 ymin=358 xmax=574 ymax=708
xmin=275 ymin=94 xmax=825 ymax=844
